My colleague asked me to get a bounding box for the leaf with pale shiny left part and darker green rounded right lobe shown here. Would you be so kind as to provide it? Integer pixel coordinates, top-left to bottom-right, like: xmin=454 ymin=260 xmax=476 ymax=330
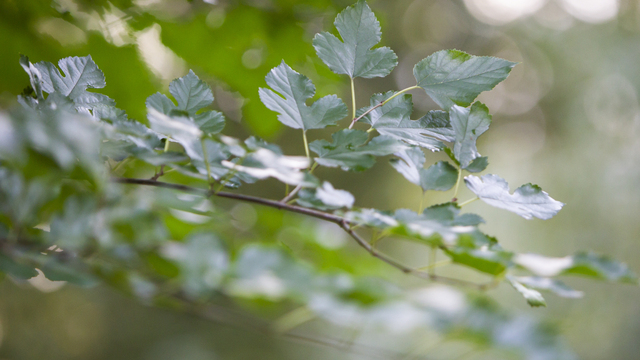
xmin=390 ymin=148 xmax=458 ymax=191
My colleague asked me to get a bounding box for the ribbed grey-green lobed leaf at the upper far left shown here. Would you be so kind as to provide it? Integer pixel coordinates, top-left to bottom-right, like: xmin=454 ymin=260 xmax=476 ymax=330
xmin=34 ymin=55 xmax=115 ymax=112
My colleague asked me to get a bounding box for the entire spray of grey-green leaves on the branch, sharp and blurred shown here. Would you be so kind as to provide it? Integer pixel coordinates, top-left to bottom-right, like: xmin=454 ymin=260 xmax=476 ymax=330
xmin=0 ymin=1 xmax=637 ymax=359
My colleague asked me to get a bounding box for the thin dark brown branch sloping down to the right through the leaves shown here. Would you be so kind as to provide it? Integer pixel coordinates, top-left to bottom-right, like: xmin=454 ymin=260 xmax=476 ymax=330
xmin=112 ymin=178 xmax=493 ymax=291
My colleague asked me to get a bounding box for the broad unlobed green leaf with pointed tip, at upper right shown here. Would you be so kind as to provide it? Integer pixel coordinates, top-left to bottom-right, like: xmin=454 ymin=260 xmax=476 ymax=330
xmin=413 ymin=50 xmax=516 ymax=110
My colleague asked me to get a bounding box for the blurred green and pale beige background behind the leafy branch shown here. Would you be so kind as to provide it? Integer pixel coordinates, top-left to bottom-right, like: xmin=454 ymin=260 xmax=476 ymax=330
xmin=0 ymin=0 xmax=640 ymax=360
